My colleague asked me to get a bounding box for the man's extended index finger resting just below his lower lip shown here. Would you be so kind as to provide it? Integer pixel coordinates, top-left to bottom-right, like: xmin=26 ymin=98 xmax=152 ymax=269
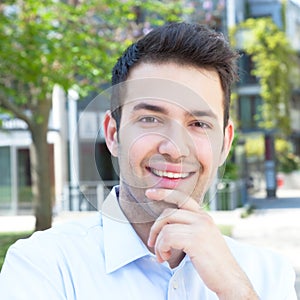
xmin=145 ymin=188 xmax=202 ymax=211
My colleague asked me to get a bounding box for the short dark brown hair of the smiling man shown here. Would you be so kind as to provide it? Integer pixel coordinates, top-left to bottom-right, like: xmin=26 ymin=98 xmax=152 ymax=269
xmin=111 ymin=23 xmax=238 ymax=128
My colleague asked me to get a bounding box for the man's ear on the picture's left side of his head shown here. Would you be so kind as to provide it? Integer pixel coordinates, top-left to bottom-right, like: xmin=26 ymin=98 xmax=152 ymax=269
xmin=103 ymin=111 xmax=118 ymax=157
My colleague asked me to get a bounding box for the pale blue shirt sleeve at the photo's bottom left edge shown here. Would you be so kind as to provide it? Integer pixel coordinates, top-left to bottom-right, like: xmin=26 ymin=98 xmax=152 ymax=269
xmin=0 ymin=239 xmax=66 ymax=300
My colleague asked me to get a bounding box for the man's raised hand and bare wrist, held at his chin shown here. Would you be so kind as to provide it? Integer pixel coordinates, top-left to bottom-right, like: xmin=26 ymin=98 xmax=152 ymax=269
xmin=146 ymin=189 xmax=258 ymax=299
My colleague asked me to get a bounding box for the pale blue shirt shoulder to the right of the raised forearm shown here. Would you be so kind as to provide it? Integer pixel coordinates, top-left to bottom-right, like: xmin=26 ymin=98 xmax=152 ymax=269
xmin=225 ymin=237 xmax=295 ymax=299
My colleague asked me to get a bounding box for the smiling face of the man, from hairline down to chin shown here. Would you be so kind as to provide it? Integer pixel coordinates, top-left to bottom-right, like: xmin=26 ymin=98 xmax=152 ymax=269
xmin=105 ymin=63 xmax=233 ymax=216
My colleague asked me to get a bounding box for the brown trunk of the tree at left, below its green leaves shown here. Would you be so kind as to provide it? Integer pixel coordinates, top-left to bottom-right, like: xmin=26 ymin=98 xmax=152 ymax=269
xmin=30 ymin=122 xmax=52 ymax=231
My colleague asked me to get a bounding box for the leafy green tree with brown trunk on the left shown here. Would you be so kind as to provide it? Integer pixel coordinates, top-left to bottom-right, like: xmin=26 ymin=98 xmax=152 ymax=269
xmin=0 ymin=0 xmax=183 ymax=230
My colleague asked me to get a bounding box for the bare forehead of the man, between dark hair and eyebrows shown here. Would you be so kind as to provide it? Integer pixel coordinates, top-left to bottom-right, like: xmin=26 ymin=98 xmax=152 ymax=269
xmin=122 ymin=63 xmax=223 ymax=119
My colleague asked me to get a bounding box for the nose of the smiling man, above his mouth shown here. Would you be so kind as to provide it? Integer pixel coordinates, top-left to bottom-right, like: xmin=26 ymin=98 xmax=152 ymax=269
xmin=158 ymin=122 xmax=191 ymax=160
